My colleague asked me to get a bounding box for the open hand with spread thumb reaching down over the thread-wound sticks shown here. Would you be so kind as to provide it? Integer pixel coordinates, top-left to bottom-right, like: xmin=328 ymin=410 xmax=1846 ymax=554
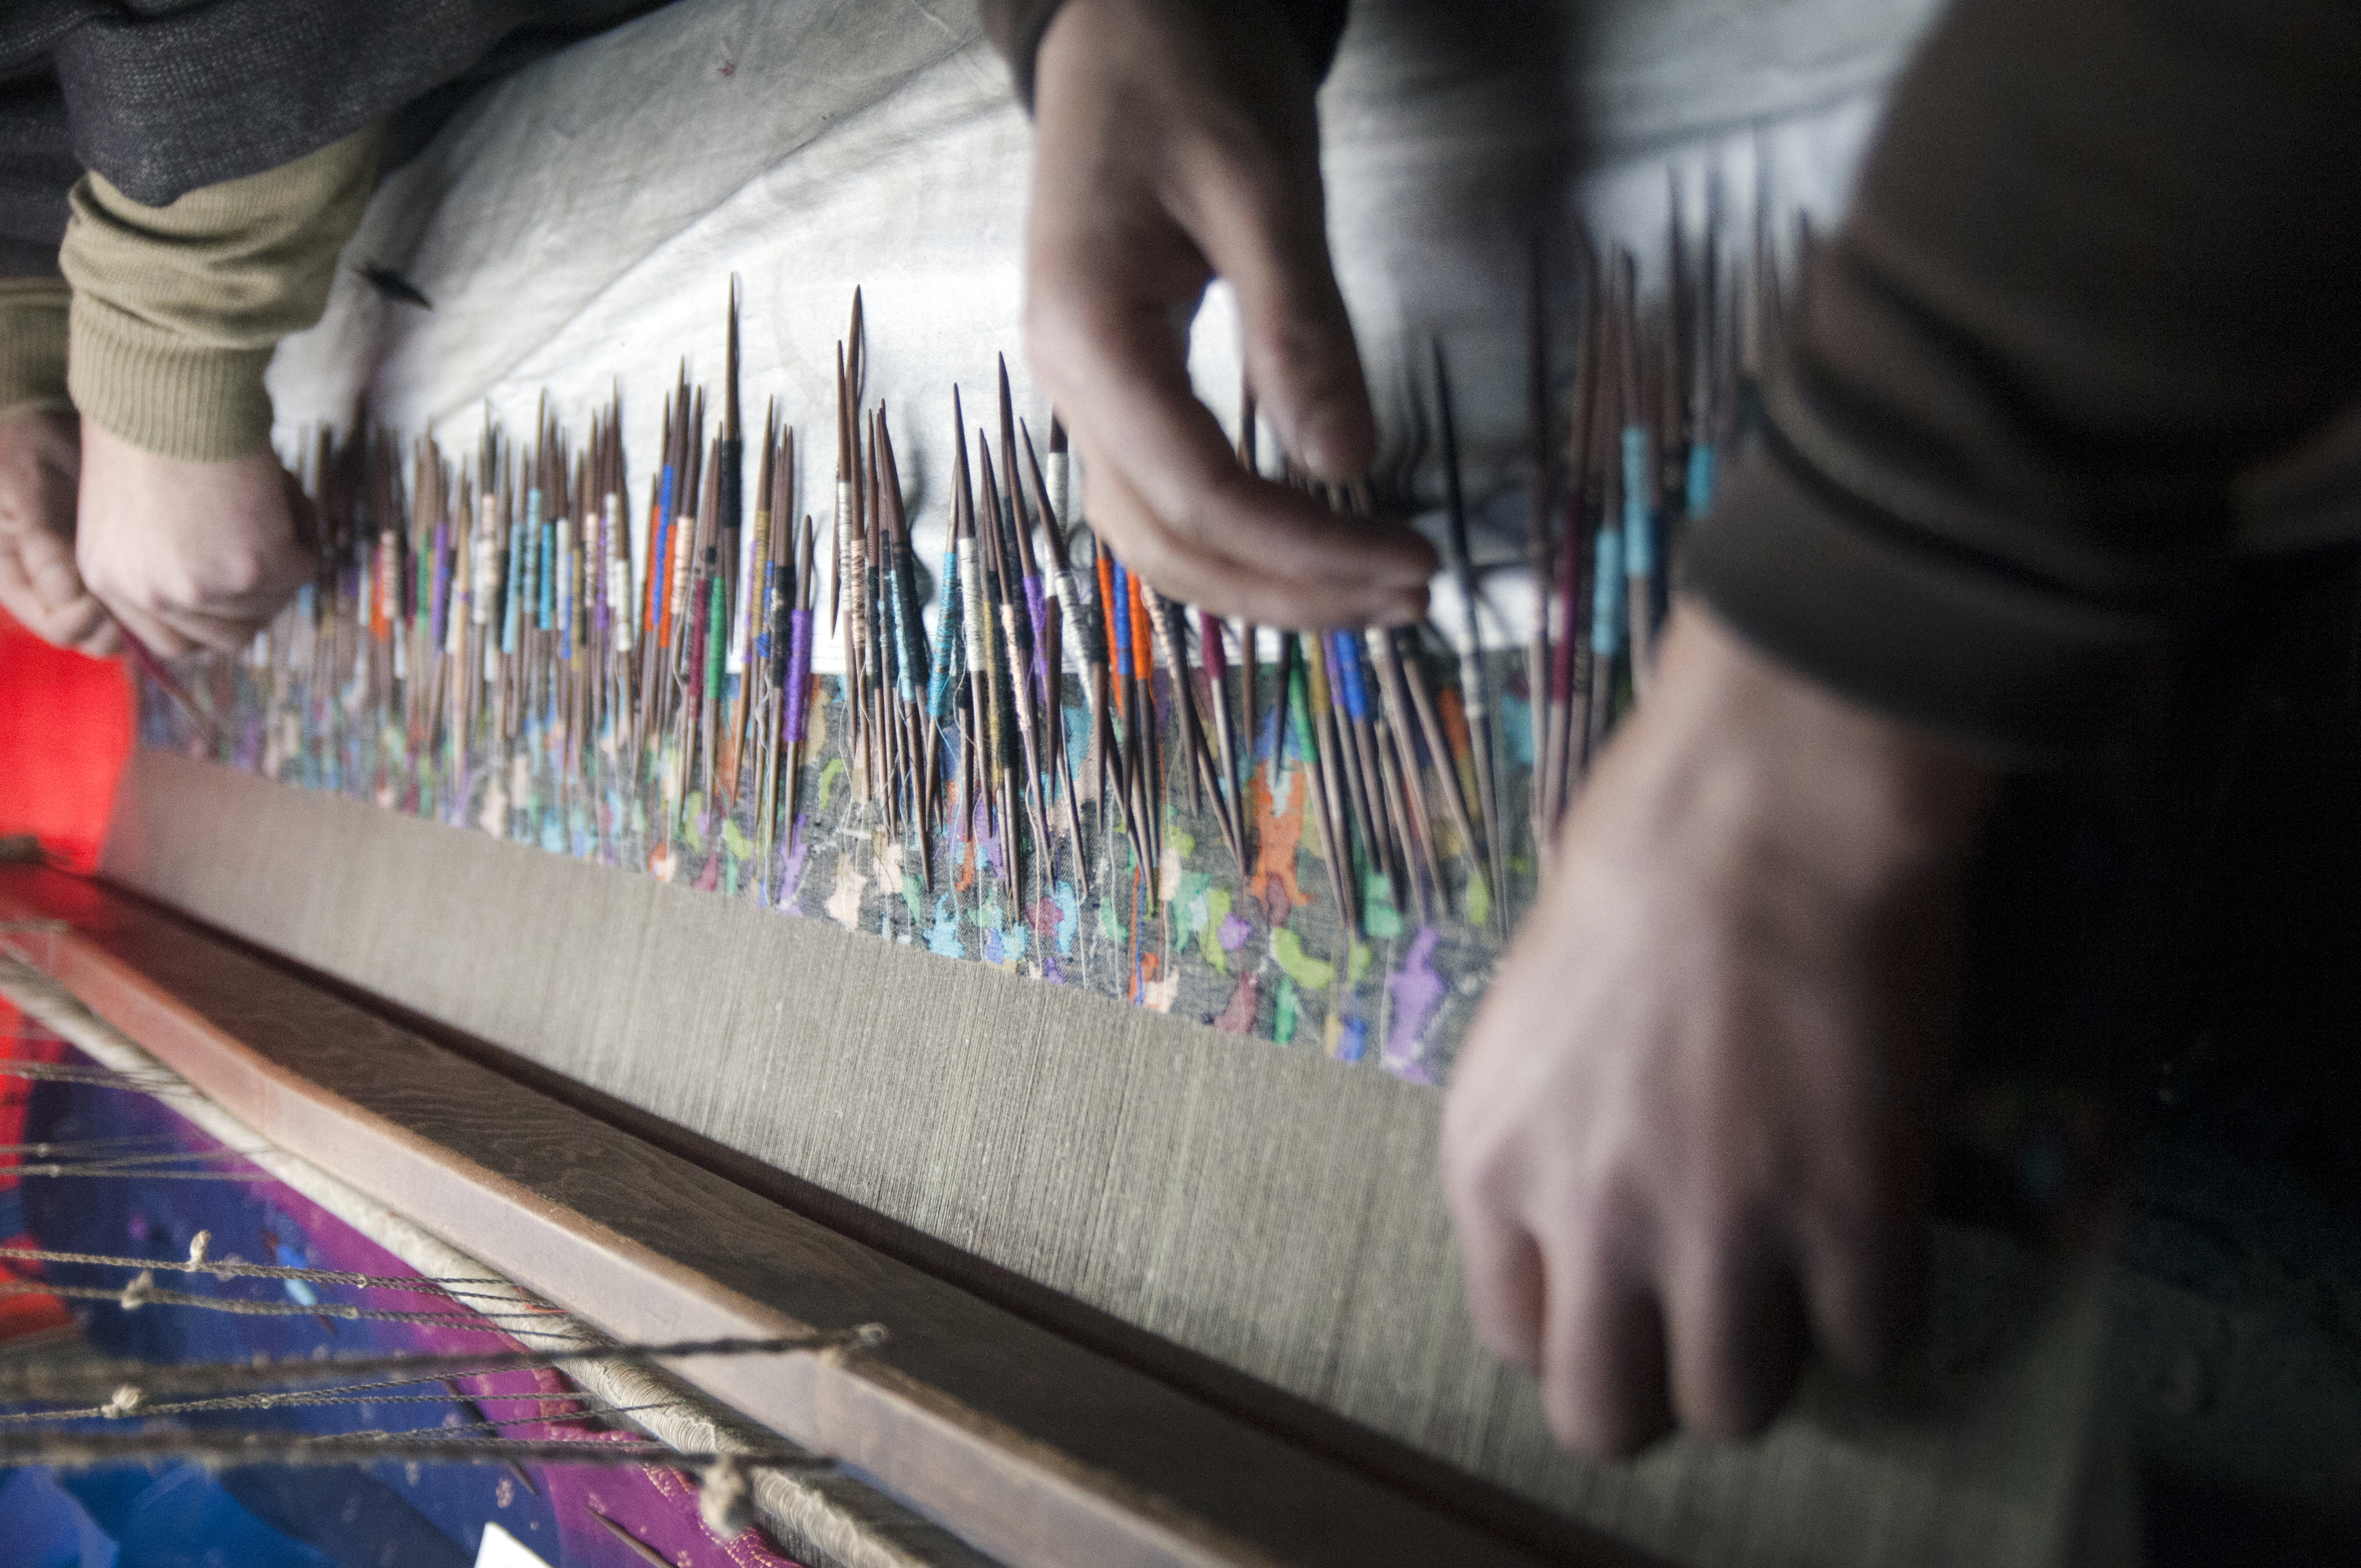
xmin=1025 ymin=0 xmax=1436 ymax=628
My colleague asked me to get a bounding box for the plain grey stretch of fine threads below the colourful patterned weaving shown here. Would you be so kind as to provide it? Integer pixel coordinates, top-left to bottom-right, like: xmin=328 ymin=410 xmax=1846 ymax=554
xmin=104 ymin=751 xmax=2111 ymax=1568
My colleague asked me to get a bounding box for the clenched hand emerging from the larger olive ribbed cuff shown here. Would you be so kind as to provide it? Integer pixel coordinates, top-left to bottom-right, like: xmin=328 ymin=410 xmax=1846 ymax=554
xmin=76 ymin=420 xmax=312 ymax=659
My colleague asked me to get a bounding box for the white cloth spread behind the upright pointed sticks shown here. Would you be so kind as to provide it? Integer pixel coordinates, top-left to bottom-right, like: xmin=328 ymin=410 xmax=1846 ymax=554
xmin=269 ymin=0 xmax=1931 ymax=668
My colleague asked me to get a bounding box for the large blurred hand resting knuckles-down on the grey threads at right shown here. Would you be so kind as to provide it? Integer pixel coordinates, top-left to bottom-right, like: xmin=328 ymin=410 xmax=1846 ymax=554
xmin=1443 ymin=605 xmax=1990 ymax=1455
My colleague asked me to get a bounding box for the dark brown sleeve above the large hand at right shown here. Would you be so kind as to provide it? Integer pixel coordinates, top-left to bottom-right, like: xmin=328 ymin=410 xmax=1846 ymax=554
xmin=1686 ymin=0 xmax=2361 ymax=758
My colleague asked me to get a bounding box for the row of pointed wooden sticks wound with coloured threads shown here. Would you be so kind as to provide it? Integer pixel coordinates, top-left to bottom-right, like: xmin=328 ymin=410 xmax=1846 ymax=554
xmin=235 ymin=210 xmax=1778 ymax=949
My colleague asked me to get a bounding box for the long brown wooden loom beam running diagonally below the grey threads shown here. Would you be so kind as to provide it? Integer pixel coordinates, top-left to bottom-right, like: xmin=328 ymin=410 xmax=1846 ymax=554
xmin=0 ymin=869 xmax=1641 ymax=1568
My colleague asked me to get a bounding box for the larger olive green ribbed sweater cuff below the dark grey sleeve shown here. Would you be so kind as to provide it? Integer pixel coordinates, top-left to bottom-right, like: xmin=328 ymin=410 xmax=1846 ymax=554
xmin=57 ymin=125 xmax=382 ymax=463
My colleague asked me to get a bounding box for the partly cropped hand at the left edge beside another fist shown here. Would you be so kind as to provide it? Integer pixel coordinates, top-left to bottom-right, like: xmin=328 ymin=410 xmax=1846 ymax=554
xmin=0 ymin=413 xmax=118 ymax=654
